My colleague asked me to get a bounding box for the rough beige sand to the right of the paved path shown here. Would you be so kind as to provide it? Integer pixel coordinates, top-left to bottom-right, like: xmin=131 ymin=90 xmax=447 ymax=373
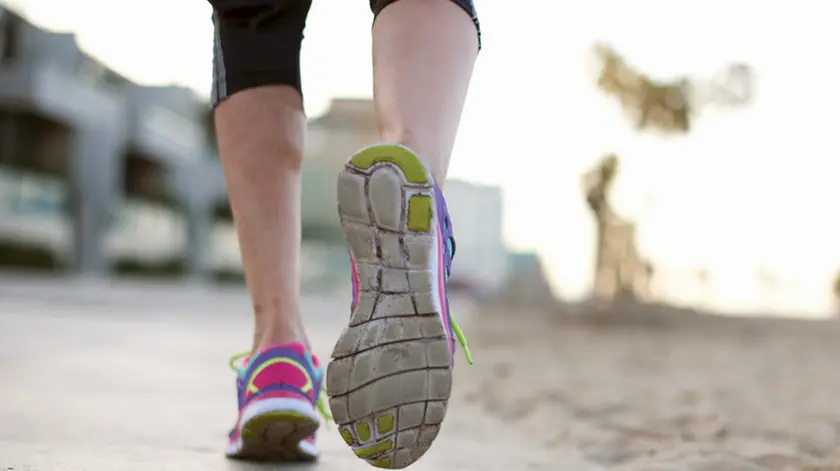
xmin=459 ymin=307 xmax=840 ymax=471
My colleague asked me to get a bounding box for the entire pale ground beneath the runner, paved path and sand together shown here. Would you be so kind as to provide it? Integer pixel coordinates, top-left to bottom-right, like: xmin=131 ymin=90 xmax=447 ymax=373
xmin=0 ymin=276 xmax=840 ymax=471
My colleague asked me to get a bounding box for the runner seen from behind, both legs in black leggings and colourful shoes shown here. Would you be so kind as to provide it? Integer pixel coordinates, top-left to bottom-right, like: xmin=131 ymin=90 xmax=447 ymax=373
xmin=210 ymin=0 xmax=480 ymax=468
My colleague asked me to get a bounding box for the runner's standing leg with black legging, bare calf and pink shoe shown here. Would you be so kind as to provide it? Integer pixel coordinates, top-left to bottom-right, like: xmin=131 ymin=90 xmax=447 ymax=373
xmin=210 ymin=0 xmax=322 ymax=461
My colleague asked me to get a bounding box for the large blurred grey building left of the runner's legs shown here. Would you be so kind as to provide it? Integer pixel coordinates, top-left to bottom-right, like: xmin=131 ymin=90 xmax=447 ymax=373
xmin=0 ymin=5 xmax=224 ymax=276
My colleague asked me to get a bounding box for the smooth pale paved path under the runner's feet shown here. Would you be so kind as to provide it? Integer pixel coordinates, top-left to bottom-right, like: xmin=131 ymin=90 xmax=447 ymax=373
xmin=0 ymin=275 xmax=556 ymax=471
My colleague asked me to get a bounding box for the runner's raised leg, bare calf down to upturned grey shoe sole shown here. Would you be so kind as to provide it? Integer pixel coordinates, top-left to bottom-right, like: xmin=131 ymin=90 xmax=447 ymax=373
xmin=327 ymin=0 xmax=479 ymax=468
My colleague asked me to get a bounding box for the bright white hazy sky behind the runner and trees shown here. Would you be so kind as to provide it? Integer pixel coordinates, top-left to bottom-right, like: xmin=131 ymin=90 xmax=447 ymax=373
xmin=6 ymin=0 xmax=840 ymax=316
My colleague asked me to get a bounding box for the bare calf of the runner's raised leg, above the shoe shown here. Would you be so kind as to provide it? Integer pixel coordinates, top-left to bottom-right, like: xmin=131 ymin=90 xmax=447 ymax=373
xmin=373 ymin=0 xmax=479 ymax=185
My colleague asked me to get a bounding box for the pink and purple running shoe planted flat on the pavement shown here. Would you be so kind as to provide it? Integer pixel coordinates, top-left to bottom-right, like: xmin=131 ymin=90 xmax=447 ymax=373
xmin=226 ymin=342 xmax=330 ymax=462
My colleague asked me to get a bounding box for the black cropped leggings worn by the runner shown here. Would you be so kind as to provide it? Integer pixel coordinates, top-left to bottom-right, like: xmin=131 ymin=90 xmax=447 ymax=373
xmin=209 ymin=0 xmax=481 ymax=106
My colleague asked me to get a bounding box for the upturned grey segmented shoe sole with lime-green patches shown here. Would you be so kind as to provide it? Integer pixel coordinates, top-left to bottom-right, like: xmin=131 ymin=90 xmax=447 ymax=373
xmin=326 ymin=144 xmax=452 ymax=469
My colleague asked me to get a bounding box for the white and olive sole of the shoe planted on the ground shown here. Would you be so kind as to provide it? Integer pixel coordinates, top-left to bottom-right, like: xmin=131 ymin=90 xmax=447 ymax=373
xmin=227 ymin=399 xmax=320 ymax=462
